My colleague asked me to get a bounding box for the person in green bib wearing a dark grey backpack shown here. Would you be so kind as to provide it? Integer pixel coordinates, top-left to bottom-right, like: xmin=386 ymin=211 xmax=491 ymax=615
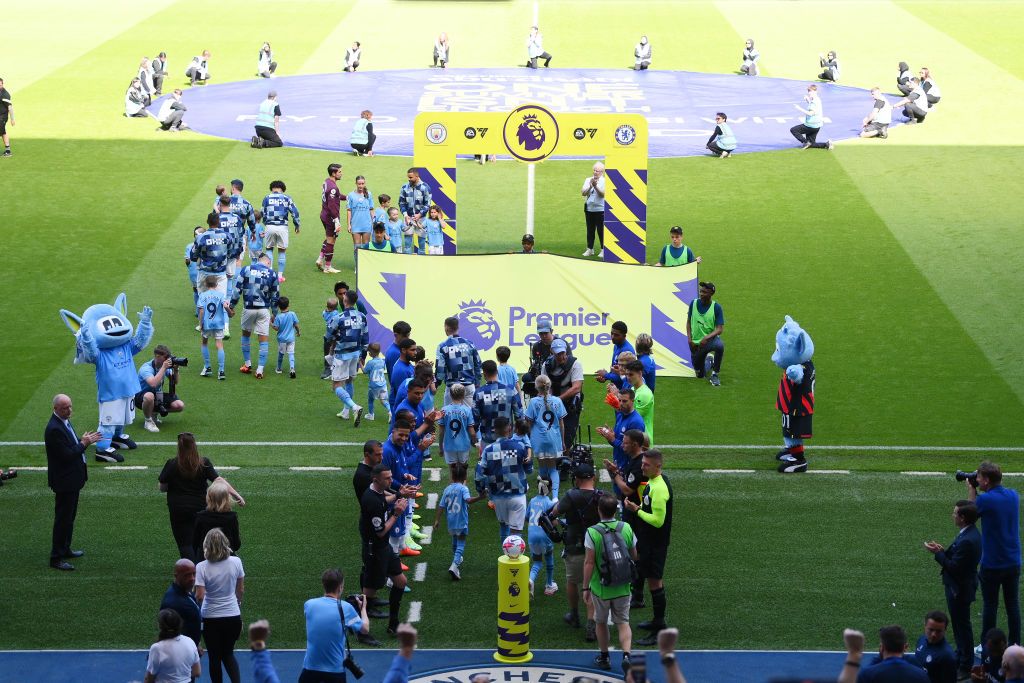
xmin=583 ymin=496 xmax=637 ymax=674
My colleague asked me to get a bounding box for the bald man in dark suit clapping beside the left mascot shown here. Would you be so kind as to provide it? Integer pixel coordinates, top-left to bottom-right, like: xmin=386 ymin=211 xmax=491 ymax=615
xmin=44 ymin=393 xmax=100 ymax=571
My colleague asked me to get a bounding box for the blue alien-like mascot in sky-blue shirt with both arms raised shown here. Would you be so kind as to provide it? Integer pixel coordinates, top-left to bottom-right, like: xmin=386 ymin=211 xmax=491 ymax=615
xmin=60 ymin=292 xmax=153 ymax=462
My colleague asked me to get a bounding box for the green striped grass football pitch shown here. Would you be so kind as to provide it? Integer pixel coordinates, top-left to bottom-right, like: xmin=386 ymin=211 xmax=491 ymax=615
xmin=0 ymin=0 xmax=1024 ymax=667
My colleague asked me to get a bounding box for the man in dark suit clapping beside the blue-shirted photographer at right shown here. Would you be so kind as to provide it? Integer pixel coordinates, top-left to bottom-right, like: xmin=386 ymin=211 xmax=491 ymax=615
xmin=925 ymin=501 xmax=981 ymax=681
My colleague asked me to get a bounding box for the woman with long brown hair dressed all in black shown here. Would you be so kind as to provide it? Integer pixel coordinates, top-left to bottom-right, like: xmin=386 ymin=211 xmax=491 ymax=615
xmin=160 ymin=432 xmax=246 ymax=560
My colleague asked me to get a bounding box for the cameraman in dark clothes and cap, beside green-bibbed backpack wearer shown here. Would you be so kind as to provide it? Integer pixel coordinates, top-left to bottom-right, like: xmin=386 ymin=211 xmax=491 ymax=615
xmin=548 ymin=462 xmax=608 ymax=643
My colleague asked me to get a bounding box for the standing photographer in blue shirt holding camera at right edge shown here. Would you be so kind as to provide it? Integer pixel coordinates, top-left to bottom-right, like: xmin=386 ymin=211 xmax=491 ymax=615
xmin=956 ymin=460 xmax=1021 ymax=645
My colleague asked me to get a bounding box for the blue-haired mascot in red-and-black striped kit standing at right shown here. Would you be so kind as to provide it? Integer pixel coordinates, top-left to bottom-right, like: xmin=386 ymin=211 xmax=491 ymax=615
xmin=771 ymin=315 xmax=814 ymax=473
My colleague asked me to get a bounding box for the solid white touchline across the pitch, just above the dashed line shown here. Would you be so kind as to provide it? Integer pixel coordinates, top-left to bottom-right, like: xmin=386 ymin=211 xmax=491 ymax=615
xmin=0 ymin=441 xmax=1024 ymax=453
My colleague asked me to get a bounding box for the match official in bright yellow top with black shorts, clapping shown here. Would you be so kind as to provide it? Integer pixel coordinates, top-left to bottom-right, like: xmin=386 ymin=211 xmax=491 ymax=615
xmin=623 ymin=450 xmax=672 ymax=647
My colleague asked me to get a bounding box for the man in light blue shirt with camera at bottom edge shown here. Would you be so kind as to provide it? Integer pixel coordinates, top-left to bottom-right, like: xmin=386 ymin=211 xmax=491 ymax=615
xmin=299 ymin=569 xmax=370 ymax=683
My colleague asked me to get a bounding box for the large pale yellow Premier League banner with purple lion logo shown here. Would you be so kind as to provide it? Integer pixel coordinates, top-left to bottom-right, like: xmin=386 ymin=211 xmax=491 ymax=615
xmin=358 ymin=250 xmax=697 ymax=377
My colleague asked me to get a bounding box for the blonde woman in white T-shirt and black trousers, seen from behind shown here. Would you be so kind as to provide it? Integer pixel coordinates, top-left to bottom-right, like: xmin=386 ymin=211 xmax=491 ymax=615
xmin=196 ymin=528 xmax=246 ymax=683
